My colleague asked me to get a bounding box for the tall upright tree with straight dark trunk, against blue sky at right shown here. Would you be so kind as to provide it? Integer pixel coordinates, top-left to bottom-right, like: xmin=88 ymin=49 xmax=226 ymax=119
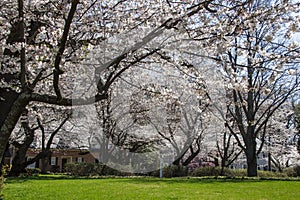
xmin=200 ymin=0 xmax=299 ymax=176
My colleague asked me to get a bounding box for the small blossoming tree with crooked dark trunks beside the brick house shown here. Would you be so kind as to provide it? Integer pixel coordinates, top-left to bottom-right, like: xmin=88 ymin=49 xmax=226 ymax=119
xmin=8 ymin=106 xmax=70 ymax=176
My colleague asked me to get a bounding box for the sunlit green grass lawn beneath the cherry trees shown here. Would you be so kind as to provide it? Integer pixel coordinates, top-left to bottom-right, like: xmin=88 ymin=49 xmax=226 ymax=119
xmin=2 ymin=176 xmax=300 ymax=200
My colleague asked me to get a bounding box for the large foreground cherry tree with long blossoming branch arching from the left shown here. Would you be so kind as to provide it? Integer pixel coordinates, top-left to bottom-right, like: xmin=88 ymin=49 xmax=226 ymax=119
xmin=0 ymin=0 xmax=299 ymax=175
